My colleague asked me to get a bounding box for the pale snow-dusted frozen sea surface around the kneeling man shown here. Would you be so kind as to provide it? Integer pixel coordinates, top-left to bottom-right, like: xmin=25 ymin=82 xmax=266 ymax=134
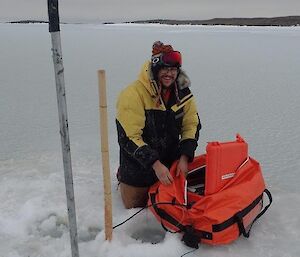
xmin=0 ymin=24 xmax=300 ymax=257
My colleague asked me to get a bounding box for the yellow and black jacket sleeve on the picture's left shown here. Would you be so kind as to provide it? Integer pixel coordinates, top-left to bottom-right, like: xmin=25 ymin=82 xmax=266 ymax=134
xmin=116 ymin=87 xmax=159 ymax=169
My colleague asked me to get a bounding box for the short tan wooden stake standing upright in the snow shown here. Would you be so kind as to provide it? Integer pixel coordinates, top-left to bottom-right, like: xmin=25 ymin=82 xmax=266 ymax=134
xmin=98 ymin=70 xmax=112 ymax=241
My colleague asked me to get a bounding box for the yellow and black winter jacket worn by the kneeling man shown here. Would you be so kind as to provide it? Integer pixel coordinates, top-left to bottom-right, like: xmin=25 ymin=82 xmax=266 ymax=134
xmin=116 ymin=62 xmax=201 ymax=187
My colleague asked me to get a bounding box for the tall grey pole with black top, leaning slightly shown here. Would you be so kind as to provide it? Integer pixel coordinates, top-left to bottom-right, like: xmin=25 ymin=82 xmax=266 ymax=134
xmin=48 ymin=0 xmax=79 ymax=257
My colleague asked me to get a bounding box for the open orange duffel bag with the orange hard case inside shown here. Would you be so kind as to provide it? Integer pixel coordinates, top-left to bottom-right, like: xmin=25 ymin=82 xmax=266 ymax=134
xmin=148 ymin=135 xmax=272 ymax=248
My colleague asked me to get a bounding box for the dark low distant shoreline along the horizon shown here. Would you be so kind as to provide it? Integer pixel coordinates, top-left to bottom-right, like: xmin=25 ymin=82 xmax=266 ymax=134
xmin=6 ymin=16 xmax=300 ymax=27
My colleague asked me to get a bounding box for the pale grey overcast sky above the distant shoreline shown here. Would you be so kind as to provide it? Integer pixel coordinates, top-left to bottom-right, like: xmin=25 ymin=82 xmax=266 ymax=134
xmin=0 ymin=0 xmax=300 ymax=22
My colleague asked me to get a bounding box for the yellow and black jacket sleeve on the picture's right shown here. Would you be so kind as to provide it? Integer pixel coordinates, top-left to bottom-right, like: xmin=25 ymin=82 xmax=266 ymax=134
xmin=179 ymin=97 xmax=201 ymax=162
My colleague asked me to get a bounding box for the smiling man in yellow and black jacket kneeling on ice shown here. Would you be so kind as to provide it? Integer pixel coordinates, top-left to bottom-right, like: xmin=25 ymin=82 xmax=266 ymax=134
xmin=116 ymin=41 xmax=201 ymax=208
